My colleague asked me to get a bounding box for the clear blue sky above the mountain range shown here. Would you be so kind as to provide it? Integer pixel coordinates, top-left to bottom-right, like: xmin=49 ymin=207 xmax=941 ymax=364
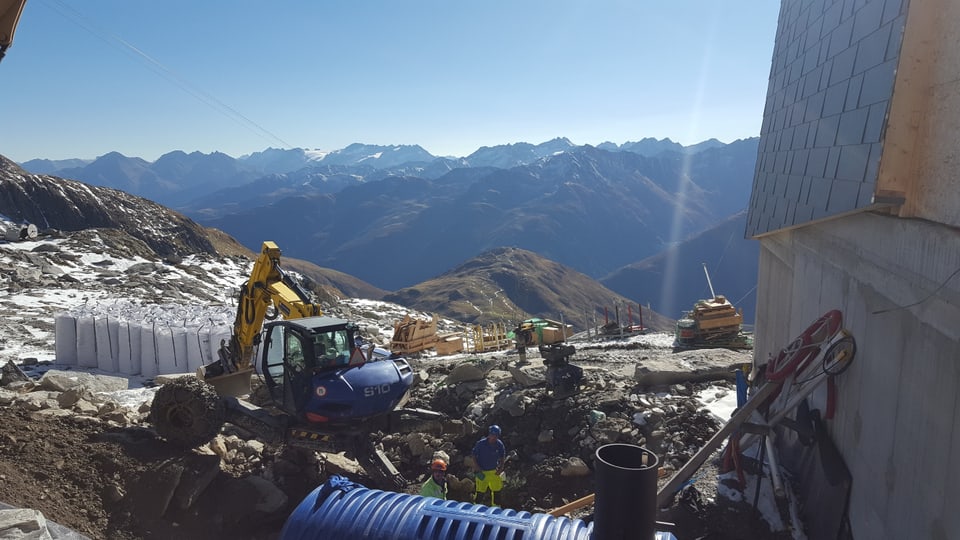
xmin=0 ymin=0 xmax=779 ymax=162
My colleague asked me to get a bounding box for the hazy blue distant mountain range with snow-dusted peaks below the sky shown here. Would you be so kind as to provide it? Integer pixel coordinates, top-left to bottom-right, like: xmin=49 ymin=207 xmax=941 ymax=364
xmin=0 ymin=139 xmax=756 ymax=324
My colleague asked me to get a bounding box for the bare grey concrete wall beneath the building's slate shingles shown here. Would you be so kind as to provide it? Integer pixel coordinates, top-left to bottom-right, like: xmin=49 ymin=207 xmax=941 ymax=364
xmin=756 ymin=213 xmax=960 ymax=540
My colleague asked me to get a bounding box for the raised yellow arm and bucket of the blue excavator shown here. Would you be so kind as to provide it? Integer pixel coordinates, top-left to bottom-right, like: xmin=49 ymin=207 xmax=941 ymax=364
xmin=208 ymin=242 xmax=323 ymax=395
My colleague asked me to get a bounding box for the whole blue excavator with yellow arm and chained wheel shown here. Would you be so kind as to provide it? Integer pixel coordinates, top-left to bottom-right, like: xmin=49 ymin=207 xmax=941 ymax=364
xmin=150 ymin=242 xmax=441 ymax=488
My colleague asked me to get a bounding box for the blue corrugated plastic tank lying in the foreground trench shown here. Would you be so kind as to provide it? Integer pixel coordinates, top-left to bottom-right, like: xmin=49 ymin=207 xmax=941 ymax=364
xmin=280 ymin=476 xmax=593 ymax=540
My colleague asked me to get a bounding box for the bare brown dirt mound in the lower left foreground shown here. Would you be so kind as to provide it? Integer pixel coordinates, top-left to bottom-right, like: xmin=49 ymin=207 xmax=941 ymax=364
xmin=0 ymin=406 xmax=292 ymax=540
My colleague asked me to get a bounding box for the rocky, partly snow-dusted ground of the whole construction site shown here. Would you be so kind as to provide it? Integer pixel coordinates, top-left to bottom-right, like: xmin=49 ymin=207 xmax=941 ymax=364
xmin=0 ymin=233 xmax=788 ymax=540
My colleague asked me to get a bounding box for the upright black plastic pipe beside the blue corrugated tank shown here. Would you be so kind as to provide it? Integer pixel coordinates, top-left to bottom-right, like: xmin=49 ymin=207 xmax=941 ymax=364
xmin=592 ymin=443 xmax=660 ymax=540
